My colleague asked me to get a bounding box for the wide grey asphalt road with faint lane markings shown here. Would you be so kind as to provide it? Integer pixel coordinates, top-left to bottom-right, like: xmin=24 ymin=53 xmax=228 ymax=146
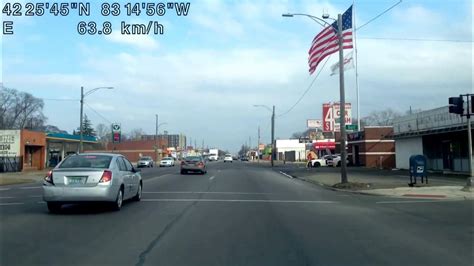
xmin=0 ymin=162 xmax=474 ymax=266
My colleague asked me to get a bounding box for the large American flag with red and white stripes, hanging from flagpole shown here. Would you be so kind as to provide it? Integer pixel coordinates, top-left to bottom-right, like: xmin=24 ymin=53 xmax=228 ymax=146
xmin=308 ymin=6 xmax=353 ymax=74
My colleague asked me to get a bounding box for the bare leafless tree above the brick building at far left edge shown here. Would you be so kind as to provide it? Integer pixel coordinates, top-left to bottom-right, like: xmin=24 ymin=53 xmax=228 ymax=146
xmin=0 ymin=85 xmax=46 ymax=129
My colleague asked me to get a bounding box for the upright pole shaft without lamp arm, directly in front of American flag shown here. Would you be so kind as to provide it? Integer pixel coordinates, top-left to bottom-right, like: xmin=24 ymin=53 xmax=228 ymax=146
xmin=337 ymin=14 xmax=348 ymax=183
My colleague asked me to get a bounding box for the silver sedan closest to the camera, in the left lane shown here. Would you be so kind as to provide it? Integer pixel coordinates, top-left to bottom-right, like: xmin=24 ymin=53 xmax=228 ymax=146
xmin=43 ymin=153 xmax=143 ymax=213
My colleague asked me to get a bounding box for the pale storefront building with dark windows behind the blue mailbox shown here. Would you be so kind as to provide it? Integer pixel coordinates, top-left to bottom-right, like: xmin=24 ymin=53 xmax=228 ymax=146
xmin=393 ymin=106 xmax=473 ymax=173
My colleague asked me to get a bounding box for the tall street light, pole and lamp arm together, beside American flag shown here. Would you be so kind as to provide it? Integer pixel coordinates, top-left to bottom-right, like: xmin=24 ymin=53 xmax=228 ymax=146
xmin=282 ymin=13 xmax=348 ymax=183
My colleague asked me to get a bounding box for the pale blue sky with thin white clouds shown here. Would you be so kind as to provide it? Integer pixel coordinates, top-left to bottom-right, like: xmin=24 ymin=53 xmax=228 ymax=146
xmin=0 ymin=0 xmax=474 ymax=152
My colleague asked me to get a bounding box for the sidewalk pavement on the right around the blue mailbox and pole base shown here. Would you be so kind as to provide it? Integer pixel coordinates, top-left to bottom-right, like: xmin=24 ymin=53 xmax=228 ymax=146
xmin=276 ymin=165 xmax=474 ymax=200
